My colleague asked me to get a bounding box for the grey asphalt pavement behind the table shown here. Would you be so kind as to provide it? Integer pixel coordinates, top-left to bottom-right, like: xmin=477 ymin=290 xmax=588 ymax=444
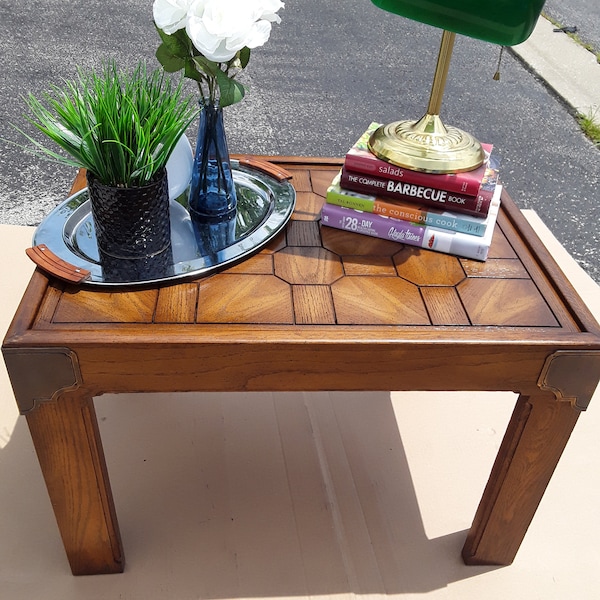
xmin=0 ymin=0 xmax=600 ymax=282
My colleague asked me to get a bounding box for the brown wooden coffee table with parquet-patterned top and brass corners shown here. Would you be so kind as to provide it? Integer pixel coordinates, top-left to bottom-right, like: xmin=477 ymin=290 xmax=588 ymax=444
xmin=3 ymin=157 xmax=600 ymax=574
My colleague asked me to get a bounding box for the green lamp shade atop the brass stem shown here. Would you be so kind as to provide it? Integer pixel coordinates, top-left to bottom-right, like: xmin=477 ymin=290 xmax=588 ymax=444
xmin=371 ymin=0 xmax=545 ymax=46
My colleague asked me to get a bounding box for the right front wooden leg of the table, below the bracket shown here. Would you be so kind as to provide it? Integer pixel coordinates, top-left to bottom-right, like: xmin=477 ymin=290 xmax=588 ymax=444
xmin=462 ymin=394 xmax=580 ymax=565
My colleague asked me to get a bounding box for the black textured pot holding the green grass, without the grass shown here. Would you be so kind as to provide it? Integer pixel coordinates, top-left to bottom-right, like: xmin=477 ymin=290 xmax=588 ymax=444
xmin=87 ymin=170 xmax=172 ymax=283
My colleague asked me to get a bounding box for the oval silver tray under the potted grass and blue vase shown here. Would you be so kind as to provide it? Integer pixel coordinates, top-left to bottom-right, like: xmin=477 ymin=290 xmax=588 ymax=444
xmin=33 ymin=160 xmax=296 ymax=286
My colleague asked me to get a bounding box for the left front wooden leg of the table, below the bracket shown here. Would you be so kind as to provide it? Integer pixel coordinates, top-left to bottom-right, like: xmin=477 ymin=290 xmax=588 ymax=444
xmin=27 ymin=388 xmax=124 ymax=575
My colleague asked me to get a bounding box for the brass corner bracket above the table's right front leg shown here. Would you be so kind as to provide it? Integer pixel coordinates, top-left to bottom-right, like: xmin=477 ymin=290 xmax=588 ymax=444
xmin=538 ymin=350 xmax=600 ymax=410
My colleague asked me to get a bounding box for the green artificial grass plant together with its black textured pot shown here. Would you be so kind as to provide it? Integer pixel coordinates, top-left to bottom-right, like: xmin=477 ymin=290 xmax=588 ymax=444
xmin=21 ymin=62 xmax=198 ymax=281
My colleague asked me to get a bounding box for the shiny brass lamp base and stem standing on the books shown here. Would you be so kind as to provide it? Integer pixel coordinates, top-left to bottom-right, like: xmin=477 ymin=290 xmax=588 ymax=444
xmin=369 ymin=31 xmax=485 ymax=173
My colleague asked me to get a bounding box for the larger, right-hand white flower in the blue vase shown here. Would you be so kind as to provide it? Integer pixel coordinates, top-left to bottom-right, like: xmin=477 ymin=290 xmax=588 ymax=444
xmin=186 ymin=0 xmax=283 ymax=62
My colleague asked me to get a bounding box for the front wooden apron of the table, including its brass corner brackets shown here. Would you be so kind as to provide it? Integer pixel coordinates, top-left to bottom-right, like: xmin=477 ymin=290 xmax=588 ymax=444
xmin=4 ymin=343 xmax=600 ymax=412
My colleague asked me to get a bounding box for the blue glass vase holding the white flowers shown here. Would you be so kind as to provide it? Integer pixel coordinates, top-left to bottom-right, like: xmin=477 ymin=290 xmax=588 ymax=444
xmin=188 ymin=101 xmax=237 ymax=224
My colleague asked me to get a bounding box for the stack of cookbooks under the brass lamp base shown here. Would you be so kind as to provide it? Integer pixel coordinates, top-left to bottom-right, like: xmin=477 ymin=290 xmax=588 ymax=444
xmin=321 ymin=123 xmax=502 ymax=261
